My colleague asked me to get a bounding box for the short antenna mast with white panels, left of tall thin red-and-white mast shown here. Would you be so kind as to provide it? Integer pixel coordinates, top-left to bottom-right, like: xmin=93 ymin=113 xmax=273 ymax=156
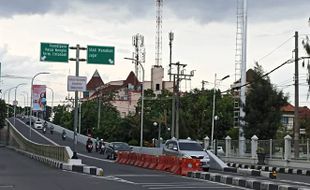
xmin=132 ymin=34 xmax=145 ymax=81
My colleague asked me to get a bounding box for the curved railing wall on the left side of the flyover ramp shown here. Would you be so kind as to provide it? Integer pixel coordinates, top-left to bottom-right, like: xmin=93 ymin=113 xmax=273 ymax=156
xmin=3 ymin=119 xmax=70 ymax=162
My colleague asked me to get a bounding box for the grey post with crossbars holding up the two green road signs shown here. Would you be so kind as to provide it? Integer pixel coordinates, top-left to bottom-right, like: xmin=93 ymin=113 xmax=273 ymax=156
xmin=70 ymin=44 xmax=86 ymax=159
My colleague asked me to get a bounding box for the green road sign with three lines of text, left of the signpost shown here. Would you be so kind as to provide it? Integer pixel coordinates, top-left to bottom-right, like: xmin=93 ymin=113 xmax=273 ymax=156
xmin=40 ymin=42 xmax=69 ymax=63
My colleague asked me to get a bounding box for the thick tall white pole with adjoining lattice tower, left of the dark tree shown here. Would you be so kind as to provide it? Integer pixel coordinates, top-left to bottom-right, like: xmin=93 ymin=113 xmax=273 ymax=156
xmin=233 ymin=0 xmax=247 ymax=154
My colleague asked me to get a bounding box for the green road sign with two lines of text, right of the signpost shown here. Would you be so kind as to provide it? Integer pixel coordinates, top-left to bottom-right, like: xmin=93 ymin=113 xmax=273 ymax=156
xmin=87 ymin=46 xmax=114 ymax=65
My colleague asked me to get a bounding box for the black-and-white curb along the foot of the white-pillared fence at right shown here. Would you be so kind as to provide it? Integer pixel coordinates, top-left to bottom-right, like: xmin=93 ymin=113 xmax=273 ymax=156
xmin=227 ymin=163 xmax=310 ymax=176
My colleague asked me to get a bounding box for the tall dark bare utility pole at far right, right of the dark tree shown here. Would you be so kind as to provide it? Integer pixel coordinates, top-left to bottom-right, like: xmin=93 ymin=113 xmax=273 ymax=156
xmin=294 ymin=31 xmax=300 ymax=159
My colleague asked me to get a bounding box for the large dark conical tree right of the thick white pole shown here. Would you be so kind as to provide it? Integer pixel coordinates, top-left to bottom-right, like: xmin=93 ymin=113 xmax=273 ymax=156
xmin=244 ymin=63 xmax=287 ymax=139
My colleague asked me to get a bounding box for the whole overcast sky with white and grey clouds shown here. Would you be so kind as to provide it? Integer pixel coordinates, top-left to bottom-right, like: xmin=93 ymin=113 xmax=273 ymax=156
xmin=0 ymin=0 xmax=310 ymax=106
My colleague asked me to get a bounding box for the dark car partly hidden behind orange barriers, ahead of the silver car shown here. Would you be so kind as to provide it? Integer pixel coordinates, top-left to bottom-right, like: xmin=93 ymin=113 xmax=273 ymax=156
xmin=104 ymin=142 xmax=132 ymax=160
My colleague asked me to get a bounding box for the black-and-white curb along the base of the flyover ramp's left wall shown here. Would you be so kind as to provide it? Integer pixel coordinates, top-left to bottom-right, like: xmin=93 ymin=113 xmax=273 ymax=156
xmin=7 ymin=146 xmax=104 ymax=176
